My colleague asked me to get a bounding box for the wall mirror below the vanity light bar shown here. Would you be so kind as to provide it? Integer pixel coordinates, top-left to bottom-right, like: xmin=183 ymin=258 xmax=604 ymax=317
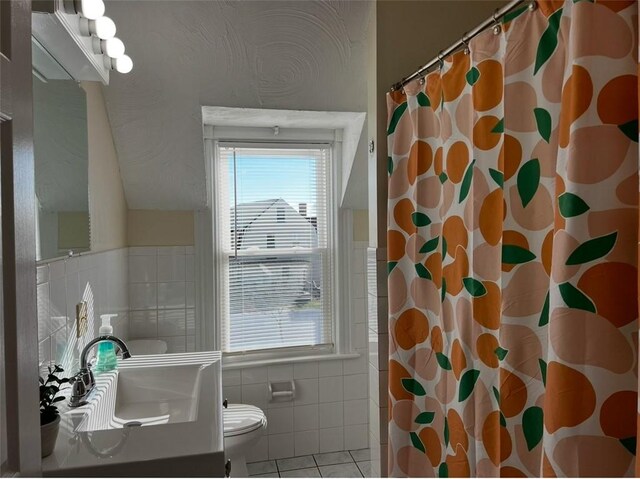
xmin=33 ymin=39 xmax=90 ymax=260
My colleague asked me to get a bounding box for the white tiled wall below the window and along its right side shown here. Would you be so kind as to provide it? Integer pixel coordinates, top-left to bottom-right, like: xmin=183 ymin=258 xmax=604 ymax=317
xmin=223 ymin=242 xmax=369 ymax=461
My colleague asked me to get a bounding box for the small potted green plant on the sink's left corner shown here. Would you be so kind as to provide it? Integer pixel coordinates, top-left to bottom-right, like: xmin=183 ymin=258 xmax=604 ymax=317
xmin=40 ymin=364 xmax=69 ymax=457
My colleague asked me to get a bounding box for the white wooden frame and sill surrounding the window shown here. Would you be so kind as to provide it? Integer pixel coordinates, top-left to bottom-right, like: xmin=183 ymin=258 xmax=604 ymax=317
xmin=201 ymin=125 xmax=359 ymax=369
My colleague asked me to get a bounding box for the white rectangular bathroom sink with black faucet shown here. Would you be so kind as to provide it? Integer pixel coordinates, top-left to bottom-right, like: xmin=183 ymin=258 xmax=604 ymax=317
xmin=43 ymin=352 xmax=224 ymax=476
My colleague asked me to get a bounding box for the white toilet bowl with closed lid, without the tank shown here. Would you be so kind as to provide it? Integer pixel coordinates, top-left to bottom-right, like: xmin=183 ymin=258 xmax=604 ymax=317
xmin=222 ymin=404 xmax=267 ymax=477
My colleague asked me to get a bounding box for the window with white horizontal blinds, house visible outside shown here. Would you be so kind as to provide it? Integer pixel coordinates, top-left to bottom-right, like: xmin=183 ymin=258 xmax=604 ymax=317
xmin=214 ymin=143 xmax=334 ymax=355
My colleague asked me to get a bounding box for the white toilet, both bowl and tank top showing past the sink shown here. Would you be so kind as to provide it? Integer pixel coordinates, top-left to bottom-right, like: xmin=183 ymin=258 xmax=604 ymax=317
xmin=127 ymin=339 xmax=267 ymax=477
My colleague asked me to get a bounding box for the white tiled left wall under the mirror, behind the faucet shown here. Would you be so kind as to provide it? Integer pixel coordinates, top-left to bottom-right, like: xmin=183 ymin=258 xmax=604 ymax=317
xmin=36 ymin=248 xmax=129 ymax=375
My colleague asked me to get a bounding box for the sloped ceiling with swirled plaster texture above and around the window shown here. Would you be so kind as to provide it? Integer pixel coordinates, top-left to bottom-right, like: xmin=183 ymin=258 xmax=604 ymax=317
xmin=104 ymin=0 xmax=373 ymax=210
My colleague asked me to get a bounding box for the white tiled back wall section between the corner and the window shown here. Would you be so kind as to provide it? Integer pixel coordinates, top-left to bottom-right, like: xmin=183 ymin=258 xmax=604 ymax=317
xmin=128 ymin=246 xmax=196 ymax=353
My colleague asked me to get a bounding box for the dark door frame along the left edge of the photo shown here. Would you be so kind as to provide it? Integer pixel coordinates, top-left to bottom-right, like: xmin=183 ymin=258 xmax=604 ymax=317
xmin=0 ymin=0 xmax=42 ymax=476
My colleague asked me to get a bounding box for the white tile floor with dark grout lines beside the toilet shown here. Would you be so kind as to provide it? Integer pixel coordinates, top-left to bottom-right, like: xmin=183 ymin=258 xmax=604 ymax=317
xmin=247 ymin=449 xmax=371 ymax=477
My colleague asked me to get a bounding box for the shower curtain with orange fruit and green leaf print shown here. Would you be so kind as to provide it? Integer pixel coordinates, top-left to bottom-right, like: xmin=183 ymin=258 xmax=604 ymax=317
xmin=387 ymin=0 xmax=640 ymax=477
